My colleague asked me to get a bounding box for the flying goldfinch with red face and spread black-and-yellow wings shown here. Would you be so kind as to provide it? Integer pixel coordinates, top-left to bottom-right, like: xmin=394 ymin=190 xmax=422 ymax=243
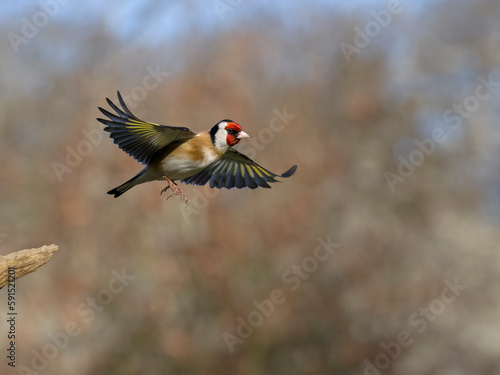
xmin=97 ymin=92 xmax=297 ymax=203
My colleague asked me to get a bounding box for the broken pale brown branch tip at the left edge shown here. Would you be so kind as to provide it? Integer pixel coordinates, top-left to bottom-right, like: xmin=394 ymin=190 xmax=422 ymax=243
xmin=0 ymin=245 xmax=59 ymax=289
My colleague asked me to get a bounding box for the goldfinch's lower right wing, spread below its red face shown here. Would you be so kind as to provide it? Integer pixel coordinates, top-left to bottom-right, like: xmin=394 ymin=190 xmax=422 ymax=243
xmin=181 ymin=149 xmax=297 ymax=189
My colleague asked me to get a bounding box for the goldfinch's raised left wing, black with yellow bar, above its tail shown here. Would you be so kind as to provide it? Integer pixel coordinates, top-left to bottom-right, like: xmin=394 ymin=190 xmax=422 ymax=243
xmin=97 ymin=91 xmax=196 ymax=165
